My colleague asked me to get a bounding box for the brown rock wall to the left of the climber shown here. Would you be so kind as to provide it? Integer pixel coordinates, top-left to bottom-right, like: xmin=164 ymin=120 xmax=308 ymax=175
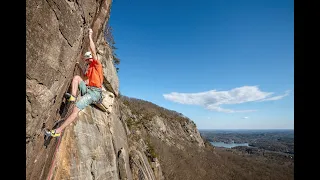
xmin=26 ymin=0 xmax=91 ymax=179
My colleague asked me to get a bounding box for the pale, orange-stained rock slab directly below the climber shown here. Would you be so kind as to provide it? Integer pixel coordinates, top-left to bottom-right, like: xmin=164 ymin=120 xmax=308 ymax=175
xmin=55 ymin=100 xmax=119 ymax=179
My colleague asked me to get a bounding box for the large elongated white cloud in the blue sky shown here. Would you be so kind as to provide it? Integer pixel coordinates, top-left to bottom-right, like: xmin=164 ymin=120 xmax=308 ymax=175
xmin=163 ymin=86 xmax=290 ymax=113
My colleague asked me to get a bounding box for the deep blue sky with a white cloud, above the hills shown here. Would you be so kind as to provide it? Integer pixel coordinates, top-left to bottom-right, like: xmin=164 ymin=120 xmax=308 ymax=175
xmin=110 ymin=0 xmax=294 ymax=129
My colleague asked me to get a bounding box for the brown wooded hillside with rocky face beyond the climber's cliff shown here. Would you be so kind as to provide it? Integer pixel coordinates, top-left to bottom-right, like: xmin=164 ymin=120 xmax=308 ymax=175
xmin=120 ymin=96 xmax=293 ymax=180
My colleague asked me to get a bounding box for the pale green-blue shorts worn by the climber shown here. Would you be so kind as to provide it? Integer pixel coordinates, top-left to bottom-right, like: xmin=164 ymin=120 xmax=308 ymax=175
xmin=76 ymin=81 xmax=102 ymax=110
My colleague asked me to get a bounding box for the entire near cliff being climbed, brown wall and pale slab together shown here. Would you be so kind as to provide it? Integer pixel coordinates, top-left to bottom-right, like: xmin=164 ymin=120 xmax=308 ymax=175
xmin=26 ymin=0 xmax=132 ymax=179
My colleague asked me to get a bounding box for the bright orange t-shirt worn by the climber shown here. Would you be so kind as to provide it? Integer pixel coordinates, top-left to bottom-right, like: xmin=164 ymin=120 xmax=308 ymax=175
xmin=86 ymin=59 xmax=103 ymax=88
